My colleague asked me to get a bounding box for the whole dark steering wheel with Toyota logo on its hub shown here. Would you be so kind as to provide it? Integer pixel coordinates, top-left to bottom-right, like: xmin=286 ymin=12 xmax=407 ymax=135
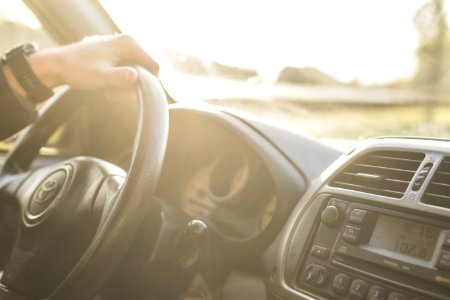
xmin=0 ymin=67 xmax=168 ymax=300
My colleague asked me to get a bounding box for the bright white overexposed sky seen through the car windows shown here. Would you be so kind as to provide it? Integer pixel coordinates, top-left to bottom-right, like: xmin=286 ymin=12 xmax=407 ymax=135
xmin=0 ymin=0 xmax=442 ymax=84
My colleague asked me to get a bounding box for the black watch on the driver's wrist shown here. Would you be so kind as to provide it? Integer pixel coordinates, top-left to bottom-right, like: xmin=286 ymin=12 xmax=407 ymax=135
xmin=2 ymin=43 xmax=53 ymax=103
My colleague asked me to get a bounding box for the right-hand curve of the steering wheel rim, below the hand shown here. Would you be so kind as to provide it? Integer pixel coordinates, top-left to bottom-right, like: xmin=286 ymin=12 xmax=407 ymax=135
xmin=49 ymin=67 xmax=169 ymax=300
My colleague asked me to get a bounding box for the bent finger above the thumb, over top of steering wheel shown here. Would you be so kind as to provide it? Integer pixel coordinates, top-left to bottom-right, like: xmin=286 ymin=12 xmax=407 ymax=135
xmin=119 ymin=35 xmax=159 ymax=76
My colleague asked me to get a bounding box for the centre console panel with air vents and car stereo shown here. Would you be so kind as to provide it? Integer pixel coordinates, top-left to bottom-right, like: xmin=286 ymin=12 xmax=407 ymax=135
xmin=270 ymin=138 xmax=450 ymax=300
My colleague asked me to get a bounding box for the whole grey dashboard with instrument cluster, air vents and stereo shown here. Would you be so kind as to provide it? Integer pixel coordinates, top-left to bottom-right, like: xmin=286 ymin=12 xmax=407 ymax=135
xmin=0 ymin=104 xmax=450 ymax=300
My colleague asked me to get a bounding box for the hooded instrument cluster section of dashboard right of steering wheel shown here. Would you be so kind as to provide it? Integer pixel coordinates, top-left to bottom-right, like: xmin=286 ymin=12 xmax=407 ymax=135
xmin=158 ymin=105 xmax=339 ymax=257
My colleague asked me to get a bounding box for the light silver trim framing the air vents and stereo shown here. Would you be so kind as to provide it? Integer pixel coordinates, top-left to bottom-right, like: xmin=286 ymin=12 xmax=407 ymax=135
xmin=271 ymin=138 xmax=450 ymax=299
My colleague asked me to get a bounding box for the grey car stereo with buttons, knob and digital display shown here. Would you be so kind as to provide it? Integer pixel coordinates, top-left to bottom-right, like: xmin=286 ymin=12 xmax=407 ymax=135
xmin=295 ymin=198 xmax=450 ymax=300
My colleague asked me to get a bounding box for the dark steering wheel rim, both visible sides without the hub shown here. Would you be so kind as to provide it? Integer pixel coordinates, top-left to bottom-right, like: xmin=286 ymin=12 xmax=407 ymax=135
xmin=0 ymin=67 xmax=168 ymax=300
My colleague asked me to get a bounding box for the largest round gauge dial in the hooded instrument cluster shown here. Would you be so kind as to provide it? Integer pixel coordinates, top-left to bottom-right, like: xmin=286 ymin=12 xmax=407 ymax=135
xmin=208 ymin=151 xmax=249 ymax=202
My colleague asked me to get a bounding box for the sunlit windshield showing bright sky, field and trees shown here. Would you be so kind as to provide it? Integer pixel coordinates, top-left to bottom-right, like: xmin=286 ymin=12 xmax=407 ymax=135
xmin=101 ymin=0 xmax=450 ymax=140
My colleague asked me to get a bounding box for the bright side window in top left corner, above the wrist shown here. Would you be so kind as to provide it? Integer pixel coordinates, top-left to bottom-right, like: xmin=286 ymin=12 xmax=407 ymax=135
xmin=0 ymin=0 xmax=55 ymax=55
